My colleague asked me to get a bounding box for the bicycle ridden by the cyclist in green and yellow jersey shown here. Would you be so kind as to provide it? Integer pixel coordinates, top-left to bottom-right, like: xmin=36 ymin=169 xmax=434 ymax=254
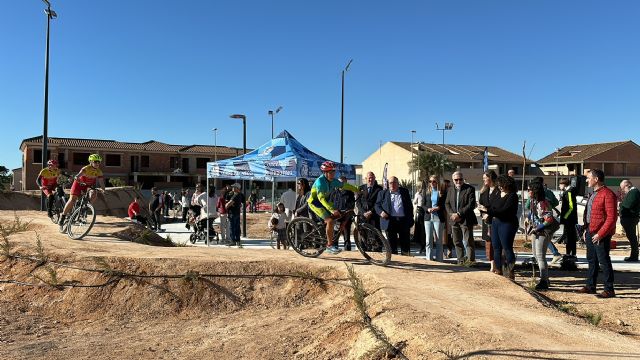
xmin=287 ymin=210 xmax=391 ymax=266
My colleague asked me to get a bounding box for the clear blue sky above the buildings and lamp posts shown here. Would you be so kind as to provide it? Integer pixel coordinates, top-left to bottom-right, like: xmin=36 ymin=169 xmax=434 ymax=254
xmin=0 ymin=0 xmax=640 ymax=168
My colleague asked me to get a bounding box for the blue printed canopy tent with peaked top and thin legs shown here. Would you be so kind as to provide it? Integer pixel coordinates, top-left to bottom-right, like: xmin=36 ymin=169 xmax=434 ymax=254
xmin=207 ymin=130 xmax=356 ymax=245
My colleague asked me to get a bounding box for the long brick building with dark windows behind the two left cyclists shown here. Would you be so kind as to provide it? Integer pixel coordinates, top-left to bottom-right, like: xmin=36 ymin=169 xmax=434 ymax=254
xmin=16 ymin=136 xmax=249 ymax=190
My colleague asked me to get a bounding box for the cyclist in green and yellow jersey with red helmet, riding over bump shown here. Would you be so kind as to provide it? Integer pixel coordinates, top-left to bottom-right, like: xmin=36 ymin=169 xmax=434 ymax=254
xmin=307 ymin=161 xmax=360 ymax=254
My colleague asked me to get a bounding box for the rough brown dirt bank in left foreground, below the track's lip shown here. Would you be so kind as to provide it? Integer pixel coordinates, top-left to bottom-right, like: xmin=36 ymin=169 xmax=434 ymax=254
xmin=0 ymin=252 xmax=374 ymax=359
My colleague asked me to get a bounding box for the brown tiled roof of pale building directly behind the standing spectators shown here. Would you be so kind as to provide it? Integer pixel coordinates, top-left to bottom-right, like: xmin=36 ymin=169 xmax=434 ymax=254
xmin=392 ymin=141 xmax=523 ymax=164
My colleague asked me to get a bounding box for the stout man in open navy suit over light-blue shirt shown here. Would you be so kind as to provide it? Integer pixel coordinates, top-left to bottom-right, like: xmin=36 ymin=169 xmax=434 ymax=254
xmin=375 ymin=176 xmax=414 ymax=256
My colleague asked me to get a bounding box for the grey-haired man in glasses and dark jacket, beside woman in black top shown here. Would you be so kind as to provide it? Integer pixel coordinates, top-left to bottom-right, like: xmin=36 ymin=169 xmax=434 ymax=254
xmin=445 ymin=171 xmax=478 ymax=264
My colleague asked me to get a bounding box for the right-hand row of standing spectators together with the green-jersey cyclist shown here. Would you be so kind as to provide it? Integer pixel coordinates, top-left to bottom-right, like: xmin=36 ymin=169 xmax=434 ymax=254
xmin=286 ymin=166 xmax=640 ymax=298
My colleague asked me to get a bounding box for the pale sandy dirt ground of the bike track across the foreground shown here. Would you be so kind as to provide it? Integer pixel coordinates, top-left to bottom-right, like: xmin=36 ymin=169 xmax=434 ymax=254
xmin=0 ymin=211 xmax=640 ymax=359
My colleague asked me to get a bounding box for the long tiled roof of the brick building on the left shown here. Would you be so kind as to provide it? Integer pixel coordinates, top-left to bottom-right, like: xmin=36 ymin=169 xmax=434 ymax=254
xmin=20 ymin=136 xmax=244 ymax=156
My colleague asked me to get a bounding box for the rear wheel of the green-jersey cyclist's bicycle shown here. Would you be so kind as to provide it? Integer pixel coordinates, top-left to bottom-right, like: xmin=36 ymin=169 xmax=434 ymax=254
xmin=287 ymin=218 xmax=327 ymax=257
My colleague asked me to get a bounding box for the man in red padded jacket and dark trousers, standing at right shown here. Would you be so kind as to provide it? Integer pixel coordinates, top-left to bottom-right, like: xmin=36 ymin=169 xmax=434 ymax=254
xmin=579 ymin=169 xmax=618 ymax=299
